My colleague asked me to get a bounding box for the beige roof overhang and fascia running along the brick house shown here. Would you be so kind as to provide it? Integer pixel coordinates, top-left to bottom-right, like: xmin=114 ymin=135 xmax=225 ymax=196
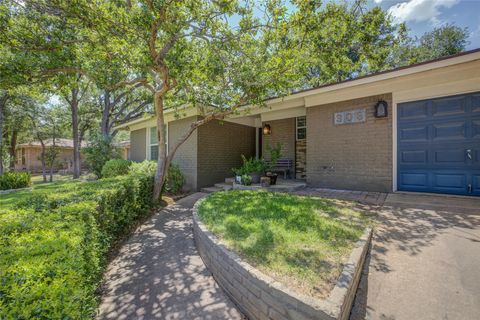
xmin=116 ymin=48 xmax=480 ymax=129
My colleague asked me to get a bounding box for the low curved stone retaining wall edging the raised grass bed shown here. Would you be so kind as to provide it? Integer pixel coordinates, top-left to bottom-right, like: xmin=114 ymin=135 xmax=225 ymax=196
xmin=193 ymin=199 xmax=372 ymax=320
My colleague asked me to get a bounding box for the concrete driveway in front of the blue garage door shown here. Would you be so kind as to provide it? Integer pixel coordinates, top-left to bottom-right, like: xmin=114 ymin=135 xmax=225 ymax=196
xmin=351 ymin=194 xmax=480 ymax=320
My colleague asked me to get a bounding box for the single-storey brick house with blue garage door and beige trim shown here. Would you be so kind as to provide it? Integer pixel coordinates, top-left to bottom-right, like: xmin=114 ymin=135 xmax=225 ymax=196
xmin=115 ymin=50 xmax=480 ymax=195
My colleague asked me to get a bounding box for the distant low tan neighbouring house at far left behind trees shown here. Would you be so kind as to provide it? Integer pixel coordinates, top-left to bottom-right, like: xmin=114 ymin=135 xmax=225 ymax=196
xmin=15 ymin=139 xmax=85 ymax=172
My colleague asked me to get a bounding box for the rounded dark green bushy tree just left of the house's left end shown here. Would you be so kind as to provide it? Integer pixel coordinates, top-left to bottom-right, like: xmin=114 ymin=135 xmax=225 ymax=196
xmin=83 ymin=133 xmax=120 ymax=178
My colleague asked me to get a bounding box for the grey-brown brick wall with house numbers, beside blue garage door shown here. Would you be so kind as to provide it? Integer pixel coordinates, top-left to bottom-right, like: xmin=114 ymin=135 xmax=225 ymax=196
xmin=307 ymin=94 xmax=392 ymax=192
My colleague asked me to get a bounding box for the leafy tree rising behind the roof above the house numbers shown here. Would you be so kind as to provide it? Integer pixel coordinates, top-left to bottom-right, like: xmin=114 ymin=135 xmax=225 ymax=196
xmin=291 ymin=0 xmax=406 ymax=88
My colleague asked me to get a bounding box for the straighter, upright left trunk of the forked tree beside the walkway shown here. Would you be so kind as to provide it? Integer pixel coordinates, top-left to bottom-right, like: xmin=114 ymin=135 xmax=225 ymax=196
xmin=153 ymin=92 xmax=167 ymax=201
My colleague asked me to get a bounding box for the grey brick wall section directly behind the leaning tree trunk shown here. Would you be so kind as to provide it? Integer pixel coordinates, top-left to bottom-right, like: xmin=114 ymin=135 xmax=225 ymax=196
xmin=168 ymin=117 xmax=198 ymax=190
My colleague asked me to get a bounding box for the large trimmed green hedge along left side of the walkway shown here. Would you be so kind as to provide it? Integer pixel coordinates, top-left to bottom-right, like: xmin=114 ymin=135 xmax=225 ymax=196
xmin=0 ymin=175 xmax=153 ymax=319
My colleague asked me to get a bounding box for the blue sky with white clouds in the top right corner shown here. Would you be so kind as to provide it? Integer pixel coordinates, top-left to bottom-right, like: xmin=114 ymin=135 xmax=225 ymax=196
xmin=368 ymin=0 xmax=480 ymax=50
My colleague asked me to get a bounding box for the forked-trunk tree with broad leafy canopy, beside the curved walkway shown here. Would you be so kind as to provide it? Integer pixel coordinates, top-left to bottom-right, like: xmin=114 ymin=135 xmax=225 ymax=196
xmin=5 ymin=0 xmax=293 ymax=199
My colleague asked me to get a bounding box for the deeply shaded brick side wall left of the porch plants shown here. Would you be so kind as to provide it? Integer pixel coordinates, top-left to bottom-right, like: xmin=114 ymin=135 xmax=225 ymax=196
xmin=197 ymin=120 xmax=255 ymax=188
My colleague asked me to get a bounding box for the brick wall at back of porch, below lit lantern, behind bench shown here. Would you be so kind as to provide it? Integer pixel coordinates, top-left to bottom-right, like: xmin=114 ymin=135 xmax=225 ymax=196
xmin=262 ymin=118 xmax=295 ymax=175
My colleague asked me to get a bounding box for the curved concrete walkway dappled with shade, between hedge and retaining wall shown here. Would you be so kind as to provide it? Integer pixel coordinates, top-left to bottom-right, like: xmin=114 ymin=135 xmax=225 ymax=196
xmin=99 ymin=193 xmax=243 ymax=320
